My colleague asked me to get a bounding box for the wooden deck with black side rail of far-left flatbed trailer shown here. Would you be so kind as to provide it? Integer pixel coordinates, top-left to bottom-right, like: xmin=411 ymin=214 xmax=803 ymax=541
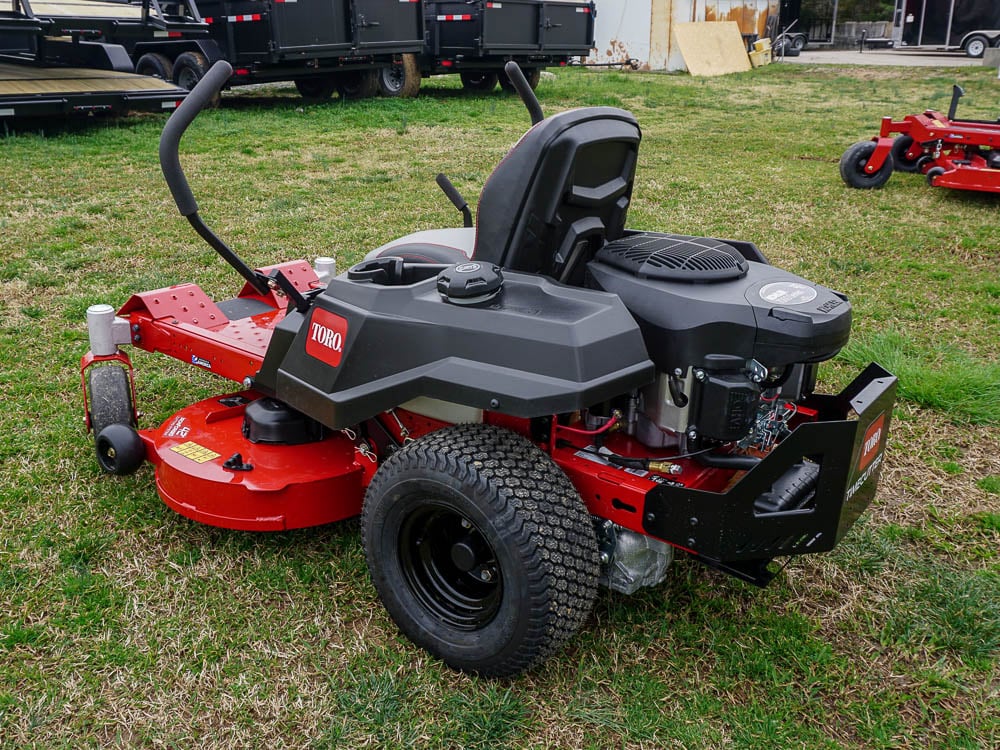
xmin=0 ymin=61 xmax=187 ymax=117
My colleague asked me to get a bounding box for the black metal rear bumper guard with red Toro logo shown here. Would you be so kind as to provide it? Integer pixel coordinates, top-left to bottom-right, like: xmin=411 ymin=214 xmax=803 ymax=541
xmin=643 ymin=364 xmax=897 ymax=585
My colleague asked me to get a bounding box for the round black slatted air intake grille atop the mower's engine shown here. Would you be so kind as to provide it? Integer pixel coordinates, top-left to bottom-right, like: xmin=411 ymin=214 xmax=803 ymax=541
xmin=596 ymin=233 xmax=749 ymax=283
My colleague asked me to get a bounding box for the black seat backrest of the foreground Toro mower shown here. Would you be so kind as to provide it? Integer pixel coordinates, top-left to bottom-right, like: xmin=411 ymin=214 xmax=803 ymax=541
xmin=473 ymin=107 xmax=642 ymax=284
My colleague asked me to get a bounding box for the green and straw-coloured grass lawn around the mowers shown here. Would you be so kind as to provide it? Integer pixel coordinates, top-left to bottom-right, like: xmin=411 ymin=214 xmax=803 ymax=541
xmin=0 ymin=65 xmax=1000 ymax=748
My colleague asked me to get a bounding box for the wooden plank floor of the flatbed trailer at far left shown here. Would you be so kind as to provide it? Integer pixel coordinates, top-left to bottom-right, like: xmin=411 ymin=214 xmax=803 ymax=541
xmin=0 ymin=63 xmax=176 ymax=96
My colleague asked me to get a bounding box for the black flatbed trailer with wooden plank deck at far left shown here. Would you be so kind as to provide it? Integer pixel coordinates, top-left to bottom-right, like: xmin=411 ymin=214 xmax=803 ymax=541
xmin=0 ymin=0 xmax=187 ymax=118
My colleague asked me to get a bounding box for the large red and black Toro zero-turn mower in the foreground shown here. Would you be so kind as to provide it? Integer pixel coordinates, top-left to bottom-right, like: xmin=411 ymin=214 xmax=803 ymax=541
xmin=81 ymin=62 xmax=896 ymax=676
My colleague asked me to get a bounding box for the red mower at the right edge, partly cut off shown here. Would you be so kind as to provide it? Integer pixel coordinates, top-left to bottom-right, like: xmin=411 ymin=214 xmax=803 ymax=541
xmin=840 ymin=86 xmax=1000 ymax=193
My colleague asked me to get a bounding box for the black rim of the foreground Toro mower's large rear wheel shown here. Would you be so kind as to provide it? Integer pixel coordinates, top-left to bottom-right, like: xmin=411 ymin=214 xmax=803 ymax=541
xmin=399 ymin=505 xmax=503 ymax=631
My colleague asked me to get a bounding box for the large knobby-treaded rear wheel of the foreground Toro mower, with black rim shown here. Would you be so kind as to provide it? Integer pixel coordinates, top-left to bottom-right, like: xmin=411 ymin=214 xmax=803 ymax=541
xmin=361 ymin=424 xmax=599 ymax=677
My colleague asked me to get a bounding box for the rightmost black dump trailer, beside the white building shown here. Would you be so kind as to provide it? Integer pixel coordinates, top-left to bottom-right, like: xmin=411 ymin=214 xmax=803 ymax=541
xmin=379 ymin=0 xmax=597 ymax=96
